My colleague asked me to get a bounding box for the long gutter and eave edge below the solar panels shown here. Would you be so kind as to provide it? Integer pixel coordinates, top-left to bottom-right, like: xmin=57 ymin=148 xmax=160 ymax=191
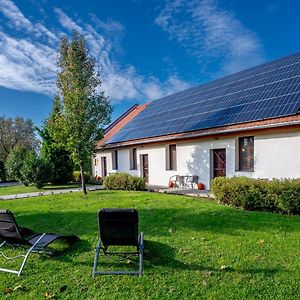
xmin=103 ymin=120 xmax=300 ymax=149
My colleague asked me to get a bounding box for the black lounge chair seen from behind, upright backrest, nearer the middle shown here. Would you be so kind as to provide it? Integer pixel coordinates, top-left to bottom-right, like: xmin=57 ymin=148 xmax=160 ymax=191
xmin=93 ymin=208 xmax=144 ymax=277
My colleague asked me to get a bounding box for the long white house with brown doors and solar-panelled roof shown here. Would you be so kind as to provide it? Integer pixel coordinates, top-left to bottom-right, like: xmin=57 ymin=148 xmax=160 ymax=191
xmin=93 ymin=53 xmax=300 ymax=189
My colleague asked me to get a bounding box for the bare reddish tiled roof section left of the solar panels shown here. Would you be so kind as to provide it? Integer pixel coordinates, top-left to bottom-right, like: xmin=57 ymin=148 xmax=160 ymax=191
xmin=96 ymin=103 xmax=148 ymax=148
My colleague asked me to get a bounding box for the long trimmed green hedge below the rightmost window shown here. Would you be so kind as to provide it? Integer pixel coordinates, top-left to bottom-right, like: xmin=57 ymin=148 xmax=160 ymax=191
xmin=212 ymin=177 xmax=300 ymax=214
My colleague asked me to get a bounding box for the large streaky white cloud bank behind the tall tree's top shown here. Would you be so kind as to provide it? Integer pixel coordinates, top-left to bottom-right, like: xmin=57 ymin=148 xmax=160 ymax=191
xmin=0 ymin=0 xmax=189 ymax=101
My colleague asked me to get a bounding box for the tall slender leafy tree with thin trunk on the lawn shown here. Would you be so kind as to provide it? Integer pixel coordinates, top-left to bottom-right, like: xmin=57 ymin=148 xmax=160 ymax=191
xmin=57 ymin=32 xmax=112 ymax=193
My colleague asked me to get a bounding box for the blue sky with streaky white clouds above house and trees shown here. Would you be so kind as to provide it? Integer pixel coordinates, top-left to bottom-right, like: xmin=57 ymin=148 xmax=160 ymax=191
xmin=0 ymin=0 xmax=300 ymax=125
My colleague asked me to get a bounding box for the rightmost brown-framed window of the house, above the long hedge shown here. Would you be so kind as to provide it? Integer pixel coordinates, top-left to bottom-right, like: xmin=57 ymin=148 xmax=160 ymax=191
xmin=238 ymin=136 xmax=254 ymax=171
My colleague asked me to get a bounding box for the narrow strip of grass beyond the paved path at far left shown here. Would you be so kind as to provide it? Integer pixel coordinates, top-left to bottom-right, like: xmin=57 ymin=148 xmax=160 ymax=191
xmin=0 ymin=183 xmax=86 ymax=196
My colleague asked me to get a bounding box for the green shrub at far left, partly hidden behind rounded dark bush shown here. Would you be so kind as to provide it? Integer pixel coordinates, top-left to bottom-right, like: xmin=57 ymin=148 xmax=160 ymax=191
xmin=5 ymin=146 xmax=29 ymax=185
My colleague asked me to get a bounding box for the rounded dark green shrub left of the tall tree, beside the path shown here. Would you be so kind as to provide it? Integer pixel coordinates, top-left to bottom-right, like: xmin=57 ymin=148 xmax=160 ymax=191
xmin=21 ymin=152 xmax=51 ymax=189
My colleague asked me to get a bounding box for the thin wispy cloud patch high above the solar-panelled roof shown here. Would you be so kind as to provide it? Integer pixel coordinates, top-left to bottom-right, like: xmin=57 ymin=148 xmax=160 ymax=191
xmin=154 ymin=0 xmax=264 ymax=73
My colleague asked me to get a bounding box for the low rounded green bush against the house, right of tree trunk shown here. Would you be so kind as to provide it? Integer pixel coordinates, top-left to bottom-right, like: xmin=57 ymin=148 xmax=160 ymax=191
xmin=103 ymin=173 xmax=146 ymax=191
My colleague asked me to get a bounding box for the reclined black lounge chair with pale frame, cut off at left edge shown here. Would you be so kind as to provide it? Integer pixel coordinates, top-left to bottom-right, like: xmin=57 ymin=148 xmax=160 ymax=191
xmin=0 ymin=210 xmax=78 ymax=276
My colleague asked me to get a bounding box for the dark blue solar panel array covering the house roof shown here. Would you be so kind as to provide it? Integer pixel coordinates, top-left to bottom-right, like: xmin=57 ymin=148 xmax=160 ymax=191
xmin=108 ymin=53 xmax=300 ymax=143
